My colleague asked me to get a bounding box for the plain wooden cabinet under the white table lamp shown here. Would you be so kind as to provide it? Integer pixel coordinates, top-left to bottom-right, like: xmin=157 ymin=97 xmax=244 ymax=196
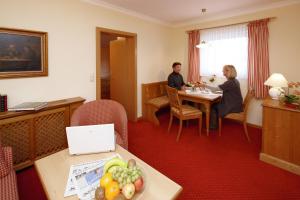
xmin=260 ymin=99 xmax=300 ymax=175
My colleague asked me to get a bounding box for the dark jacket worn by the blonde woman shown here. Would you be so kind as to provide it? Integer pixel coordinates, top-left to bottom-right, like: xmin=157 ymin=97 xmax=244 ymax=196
xmin=218 ymin=78 xmax=243 ymax=117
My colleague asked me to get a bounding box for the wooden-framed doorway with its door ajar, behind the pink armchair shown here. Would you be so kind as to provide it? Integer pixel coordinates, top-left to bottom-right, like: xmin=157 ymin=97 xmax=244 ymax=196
xmin=96 ymin=27 xmax=137 ymax=121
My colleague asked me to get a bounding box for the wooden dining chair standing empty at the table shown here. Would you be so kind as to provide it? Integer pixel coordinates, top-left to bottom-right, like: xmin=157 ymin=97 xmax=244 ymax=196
xmin=166 ymin=86 xmax=202 ymax=141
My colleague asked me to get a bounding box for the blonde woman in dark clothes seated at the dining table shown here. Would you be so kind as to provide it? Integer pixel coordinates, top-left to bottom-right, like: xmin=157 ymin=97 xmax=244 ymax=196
xmin=203 ymin=65 xmax=243 ymax=129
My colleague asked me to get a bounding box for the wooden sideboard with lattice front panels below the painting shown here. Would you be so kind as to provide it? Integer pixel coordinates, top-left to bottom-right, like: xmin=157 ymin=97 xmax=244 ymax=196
xmin=0 ymin=97 xmax=85 ymax=170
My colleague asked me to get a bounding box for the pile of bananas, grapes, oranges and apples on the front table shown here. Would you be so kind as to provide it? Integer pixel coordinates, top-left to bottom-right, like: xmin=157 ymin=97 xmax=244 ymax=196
xmin=95 ymin=157 xmax=145 ymax=200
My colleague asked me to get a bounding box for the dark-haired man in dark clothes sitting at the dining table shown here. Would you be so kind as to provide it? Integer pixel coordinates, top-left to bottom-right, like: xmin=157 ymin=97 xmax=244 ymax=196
xmin=168 ymin=62 xmax=185 ymax=90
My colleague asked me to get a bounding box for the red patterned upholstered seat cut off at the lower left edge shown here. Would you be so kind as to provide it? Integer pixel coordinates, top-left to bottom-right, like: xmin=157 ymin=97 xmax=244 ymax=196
xmin=0 ymin=140 xmax=19 ymax=200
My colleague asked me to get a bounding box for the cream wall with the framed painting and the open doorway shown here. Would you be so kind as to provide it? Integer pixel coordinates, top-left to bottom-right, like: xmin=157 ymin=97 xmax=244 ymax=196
xmin=0 ymin=0 xmax=176 ymax=116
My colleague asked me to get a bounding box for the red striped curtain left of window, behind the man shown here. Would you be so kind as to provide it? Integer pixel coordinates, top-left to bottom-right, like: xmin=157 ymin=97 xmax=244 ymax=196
xmin=187 ymin=30 xmax=200 ymax=82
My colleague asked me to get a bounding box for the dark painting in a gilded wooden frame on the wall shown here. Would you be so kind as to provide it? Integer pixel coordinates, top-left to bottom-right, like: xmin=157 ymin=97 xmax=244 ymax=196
xmin=0 ymin=27 xmax=48 ymax=79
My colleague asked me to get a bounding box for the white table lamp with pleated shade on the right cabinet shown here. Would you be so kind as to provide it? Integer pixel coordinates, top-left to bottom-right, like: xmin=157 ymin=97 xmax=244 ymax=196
xmin=264 ymin=73 xmax=288 ymax=99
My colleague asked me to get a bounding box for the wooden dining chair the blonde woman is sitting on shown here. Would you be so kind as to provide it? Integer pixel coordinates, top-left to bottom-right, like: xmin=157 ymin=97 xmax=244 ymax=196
xmin=219 ymin=90 xmax=253 ymax=142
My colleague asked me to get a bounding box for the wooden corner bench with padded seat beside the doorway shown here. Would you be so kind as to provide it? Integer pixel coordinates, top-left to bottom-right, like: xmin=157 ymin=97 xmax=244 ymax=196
xmin=142 ymin=81 xmax=169 ymax=125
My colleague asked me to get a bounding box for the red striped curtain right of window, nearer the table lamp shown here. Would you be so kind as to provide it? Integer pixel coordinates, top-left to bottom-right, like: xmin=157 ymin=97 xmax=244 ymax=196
xmin=248 ymin=19 xmax=270 ymax=99
